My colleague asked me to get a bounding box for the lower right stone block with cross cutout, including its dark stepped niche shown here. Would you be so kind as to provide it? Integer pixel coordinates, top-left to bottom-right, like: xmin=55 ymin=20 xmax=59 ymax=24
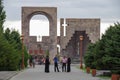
xmin=60 ymin=18 xmax=100 ymax=62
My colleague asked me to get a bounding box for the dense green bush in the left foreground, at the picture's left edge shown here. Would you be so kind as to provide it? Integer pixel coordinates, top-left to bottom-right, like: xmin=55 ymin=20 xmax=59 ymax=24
xmin=0 ymin=34 xmax=19 ymax=71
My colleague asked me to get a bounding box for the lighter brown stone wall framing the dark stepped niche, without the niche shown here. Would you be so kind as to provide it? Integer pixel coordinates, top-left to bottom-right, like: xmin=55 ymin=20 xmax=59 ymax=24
xmin=60 ymin=18 xmax=100 ymax=57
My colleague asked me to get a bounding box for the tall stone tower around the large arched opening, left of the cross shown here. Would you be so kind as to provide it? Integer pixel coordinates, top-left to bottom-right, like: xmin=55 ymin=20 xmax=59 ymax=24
xmin=22 ymin=7 xmax=57 ymax=59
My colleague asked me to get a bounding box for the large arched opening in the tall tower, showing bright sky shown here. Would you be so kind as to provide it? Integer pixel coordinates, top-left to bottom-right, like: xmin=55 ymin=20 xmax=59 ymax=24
xmin=29 ymin=14 xmax=50 ymax=42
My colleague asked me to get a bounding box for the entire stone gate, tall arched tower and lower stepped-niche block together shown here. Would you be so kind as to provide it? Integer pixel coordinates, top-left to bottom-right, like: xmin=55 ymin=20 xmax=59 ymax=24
xmin=22 ymin=7 xmax=100 ymax=61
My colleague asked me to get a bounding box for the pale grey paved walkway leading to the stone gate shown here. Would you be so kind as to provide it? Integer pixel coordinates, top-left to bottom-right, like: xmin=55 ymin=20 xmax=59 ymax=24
xmin=10 ymin=65 xmax=109 ymax=80
